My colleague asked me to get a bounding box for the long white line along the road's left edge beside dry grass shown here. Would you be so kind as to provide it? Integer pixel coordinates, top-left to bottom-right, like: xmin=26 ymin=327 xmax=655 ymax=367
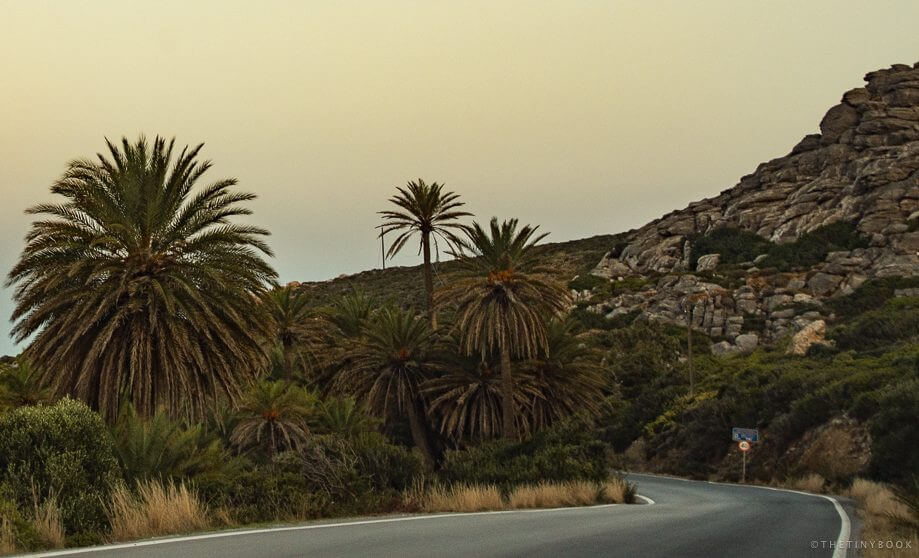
xmin=21 ymin=504 xmax=654 ymax=558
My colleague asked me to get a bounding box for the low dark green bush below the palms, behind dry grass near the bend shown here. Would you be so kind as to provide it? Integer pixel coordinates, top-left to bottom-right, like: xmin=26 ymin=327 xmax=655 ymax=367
xmin=440 ymin=418 xmax=608 ymax=490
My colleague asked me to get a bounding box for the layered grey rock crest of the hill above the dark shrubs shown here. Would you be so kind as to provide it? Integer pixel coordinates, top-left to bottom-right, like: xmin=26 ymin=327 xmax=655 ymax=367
xmin=597 ymin=63 xmax=919 ymax=282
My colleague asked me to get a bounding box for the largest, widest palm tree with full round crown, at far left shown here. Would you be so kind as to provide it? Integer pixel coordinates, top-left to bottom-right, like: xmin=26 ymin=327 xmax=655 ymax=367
xmin=7 ymin=137 xmax=276 ymax=419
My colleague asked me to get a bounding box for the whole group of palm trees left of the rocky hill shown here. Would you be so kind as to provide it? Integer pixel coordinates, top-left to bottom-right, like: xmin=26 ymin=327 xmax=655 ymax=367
xmin=8 ymin=137 xmax=605 ymax=466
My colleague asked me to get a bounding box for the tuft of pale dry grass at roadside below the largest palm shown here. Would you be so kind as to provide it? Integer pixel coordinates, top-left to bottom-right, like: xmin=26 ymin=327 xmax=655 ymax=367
xmin=109 ymin=481 xmax=208 ymax=541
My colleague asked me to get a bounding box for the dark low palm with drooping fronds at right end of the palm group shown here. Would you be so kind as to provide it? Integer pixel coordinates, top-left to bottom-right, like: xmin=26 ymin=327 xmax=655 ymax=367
xmin=521 ymin=319 xmax=605 ymax=429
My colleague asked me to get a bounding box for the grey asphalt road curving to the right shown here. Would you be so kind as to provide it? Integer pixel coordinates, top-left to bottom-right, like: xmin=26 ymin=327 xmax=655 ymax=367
xmin=30 ymin=475 xmax=850 ymax=558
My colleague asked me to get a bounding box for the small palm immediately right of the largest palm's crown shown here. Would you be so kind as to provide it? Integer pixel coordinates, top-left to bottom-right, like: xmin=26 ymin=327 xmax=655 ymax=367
xmin=263 ymin=285 xmax=329 ymax=382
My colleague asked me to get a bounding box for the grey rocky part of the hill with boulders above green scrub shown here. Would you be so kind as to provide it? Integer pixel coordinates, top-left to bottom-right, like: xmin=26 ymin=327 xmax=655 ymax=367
xmin=580 ymin=63 xmax=919 ymax=352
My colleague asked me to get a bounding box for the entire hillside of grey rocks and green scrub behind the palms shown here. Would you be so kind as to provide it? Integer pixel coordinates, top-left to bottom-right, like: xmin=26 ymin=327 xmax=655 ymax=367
xmin=294 ymin=60 xmax=919 ymax=483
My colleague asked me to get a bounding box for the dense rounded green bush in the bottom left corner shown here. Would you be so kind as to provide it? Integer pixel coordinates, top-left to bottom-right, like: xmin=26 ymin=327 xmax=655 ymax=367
xmin=0 ymin=399 xmax=121 ymax=533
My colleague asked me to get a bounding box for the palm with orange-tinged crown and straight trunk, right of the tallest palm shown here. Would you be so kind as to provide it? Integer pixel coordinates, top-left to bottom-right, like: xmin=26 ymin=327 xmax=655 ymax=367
xmin=437 ymin=218 xmax=568 ymax=438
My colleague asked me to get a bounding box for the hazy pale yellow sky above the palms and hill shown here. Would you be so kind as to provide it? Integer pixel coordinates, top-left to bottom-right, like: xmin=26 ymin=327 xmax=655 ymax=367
xmin=0 ymin=0 xmax=919 ymax=354
